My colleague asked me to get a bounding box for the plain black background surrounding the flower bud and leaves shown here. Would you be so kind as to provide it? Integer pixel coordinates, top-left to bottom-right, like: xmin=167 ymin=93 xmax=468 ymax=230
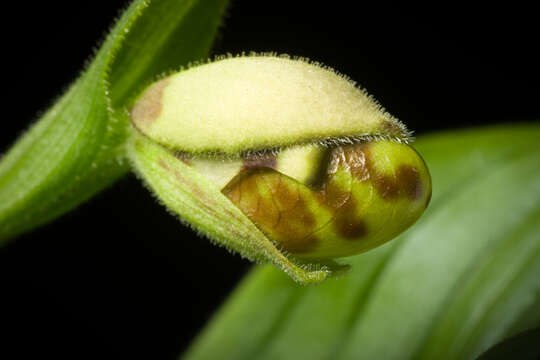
xmin=0 ymin=0 xmax=540 ymax=359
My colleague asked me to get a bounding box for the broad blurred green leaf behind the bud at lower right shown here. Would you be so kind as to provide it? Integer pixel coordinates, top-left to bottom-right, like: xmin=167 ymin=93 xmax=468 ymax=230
xmin=185 ymin=125 xmax=540 ymax=359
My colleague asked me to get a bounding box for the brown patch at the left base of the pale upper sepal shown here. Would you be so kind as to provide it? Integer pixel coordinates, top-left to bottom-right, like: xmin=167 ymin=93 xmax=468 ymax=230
xmin=130 ymin=79 xmax=170 ymax=127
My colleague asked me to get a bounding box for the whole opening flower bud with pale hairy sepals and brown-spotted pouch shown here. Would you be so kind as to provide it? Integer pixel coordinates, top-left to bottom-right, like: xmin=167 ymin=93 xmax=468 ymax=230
xmin=130 ymin=56 xmax=431 ymax=283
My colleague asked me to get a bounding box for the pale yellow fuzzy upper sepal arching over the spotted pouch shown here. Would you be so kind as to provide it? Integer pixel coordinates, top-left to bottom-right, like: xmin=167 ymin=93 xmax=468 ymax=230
xmin=131 ymin=56 xmax=408 ymax=156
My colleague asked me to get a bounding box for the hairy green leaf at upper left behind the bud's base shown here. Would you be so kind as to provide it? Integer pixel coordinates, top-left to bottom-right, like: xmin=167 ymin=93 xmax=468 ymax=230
xmin=0 ymin=0 xmax=226 ymax=244
